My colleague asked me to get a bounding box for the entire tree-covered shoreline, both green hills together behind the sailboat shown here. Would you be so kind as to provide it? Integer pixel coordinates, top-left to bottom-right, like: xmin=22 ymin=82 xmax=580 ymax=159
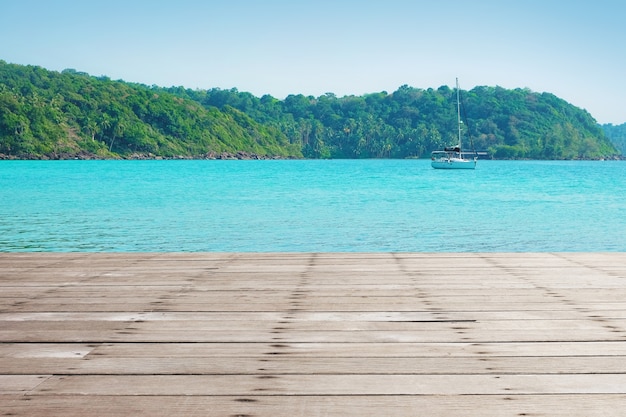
xmin=0 ymin=61 xmax=619 ymax=159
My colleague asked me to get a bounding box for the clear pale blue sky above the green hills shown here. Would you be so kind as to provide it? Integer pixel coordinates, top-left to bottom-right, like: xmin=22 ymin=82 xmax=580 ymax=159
xmin=0 ymin=0 xmax=626 ymax=124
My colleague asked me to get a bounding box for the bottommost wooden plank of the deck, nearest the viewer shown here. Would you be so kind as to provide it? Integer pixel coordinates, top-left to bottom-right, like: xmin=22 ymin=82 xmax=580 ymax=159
xmin=2 ymin=394 xmax=626 ymax=417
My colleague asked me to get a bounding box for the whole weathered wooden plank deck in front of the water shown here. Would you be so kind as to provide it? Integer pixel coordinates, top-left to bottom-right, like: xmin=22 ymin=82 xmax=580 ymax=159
xmin=0 ymin=253 xmax=626 ymax=417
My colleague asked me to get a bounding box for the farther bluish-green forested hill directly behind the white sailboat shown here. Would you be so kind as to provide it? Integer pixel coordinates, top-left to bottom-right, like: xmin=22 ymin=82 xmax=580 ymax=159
xmin=179 ymin=85 xmax=618 ymax=159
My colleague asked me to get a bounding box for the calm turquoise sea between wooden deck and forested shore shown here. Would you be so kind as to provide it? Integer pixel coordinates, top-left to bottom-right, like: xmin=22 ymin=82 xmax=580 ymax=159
xmin=0 ymin=160 xmax=626 ymax=252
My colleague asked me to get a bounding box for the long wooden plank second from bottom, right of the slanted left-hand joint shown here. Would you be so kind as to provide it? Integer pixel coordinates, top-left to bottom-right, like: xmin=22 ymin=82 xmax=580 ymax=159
xmin=29 ymin=374 xmax=626 ymax=396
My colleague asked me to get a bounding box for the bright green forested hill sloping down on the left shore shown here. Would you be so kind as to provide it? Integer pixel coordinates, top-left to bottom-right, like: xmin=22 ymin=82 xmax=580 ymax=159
xmin=0 ymin=61 xmax=301 ymax=158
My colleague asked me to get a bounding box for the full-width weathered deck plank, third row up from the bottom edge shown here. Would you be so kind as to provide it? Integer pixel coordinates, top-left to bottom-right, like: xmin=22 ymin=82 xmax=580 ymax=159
xmin=0 ymin=355 xmax=626 ymax=375
